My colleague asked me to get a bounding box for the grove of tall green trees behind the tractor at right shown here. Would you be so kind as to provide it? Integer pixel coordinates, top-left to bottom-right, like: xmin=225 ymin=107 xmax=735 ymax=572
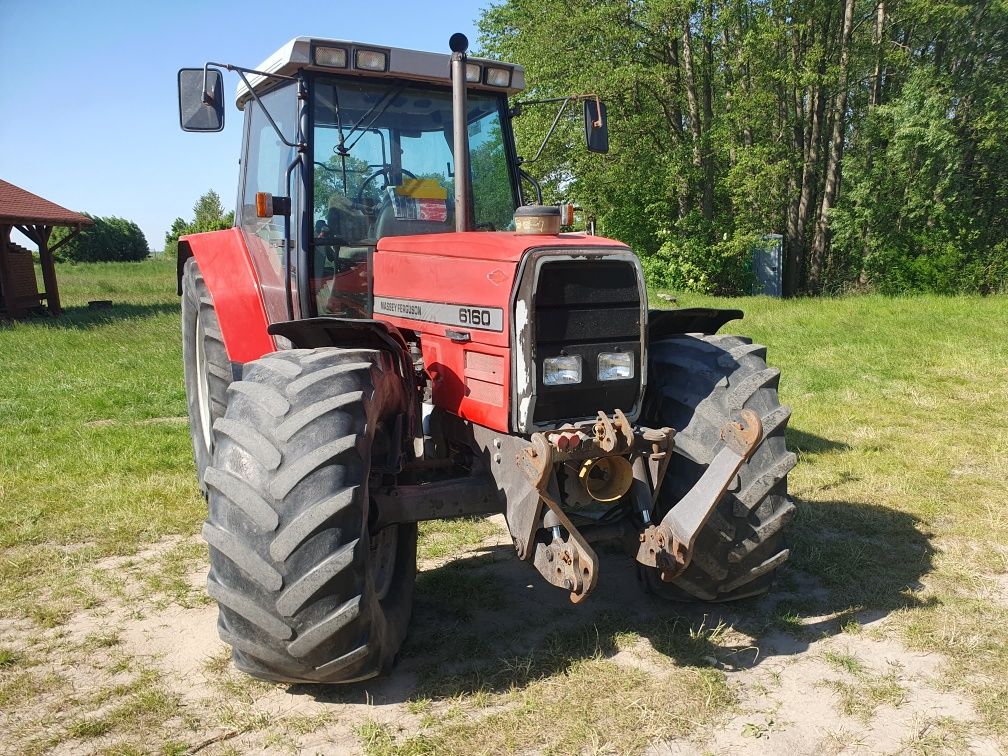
xmin=479 ymin=0 xmax=1008 ymax=294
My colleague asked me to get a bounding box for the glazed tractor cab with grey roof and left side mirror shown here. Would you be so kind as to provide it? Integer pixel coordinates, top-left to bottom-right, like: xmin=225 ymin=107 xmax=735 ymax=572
xmin=179 ymin=35 xmax=524 ymax=323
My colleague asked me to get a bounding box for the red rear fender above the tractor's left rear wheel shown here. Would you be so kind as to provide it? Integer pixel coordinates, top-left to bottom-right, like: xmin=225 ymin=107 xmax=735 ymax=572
xmin=177 ymin=228 xmax=276 ymax=363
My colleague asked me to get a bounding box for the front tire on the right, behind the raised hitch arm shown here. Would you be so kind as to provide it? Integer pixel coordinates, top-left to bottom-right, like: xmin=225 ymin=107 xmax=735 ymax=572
xmin=641 ymin=336 xmax=796 ymax=601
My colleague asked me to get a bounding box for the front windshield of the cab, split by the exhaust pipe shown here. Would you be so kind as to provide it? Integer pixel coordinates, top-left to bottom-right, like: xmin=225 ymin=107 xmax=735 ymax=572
xmin=311 ymin=78 xmax=515 ymax=317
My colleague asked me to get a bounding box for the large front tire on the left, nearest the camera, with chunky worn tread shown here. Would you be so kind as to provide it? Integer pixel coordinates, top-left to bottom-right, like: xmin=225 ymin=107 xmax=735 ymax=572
xmin=203 ymin=349 xmax=416 ymax=682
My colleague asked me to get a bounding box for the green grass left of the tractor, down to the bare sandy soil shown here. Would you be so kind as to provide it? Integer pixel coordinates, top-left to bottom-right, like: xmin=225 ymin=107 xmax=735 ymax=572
xmin=0 ymin=260 xmax=203 ymax=626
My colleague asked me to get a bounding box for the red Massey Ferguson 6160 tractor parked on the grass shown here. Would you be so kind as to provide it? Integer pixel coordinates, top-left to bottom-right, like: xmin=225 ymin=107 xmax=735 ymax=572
xmin=178 ymin=34 xmax=795 ymax=682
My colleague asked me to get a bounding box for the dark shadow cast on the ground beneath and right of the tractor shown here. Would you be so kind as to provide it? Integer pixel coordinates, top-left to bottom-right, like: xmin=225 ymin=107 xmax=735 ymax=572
xmin=290 ymin=501 xmax=933 ymax=704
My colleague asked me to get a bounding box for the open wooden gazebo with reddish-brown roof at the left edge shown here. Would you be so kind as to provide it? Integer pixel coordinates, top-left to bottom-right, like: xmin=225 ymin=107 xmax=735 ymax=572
xmin=0 ymin=179 xmax=93 ymax=318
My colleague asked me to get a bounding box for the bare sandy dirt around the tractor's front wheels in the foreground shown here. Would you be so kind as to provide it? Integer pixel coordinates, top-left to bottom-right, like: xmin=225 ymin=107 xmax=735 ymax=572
xmin=0 ymin=518 xmax=1005 ymax=756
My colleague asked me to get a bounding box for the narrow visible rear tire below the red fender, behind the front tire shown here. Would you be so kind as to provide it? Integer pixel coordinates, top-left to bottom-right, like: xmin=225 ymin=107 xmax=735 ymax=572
xmin=182 ymin=257 xmax=233 ymax=496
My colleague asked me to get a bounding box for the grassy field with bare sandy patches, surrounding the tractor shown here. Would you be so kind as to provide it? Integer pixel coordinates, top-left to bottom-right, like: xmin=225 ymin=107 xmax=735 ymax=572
xmin=0 ymin=261 xmax=1008 ymax=753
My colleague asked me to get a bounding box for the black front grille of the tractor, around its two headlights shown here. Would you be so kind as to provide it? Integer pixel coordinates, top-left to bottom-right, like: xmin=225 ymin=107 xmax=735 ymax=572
xmin=532 ymin=256 xmax=641 ymax=424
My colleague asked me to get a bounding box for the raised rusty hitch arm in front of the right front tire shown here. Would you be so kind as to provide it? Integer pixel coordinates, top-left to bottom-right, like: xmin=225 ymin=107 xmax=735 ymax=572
xmin=637 ymin=409 xmax=763 ymax=583
